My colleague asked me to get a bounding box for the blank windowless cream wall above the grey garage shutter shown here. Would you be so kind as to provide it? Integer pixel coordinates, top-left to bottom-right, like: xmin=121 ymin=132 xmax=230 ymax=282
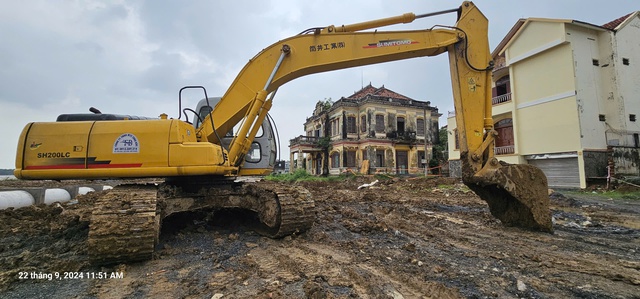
xmin=506 ymin=40 xmax=580 ymax=155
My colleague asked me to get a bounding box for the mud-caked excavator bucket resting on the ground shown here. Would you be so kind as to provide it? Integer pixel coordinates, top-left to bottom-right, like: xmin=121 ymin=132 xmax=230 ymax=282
xmin=463 ymin=156 xmax=553 ymax=232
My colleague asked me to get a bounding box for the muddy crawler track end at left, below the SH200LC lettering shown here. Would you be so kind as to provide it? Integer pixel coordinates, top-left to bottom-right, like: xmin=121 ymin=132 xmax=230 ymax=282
xmin=88 ymin=185 xmax=160 ymax=264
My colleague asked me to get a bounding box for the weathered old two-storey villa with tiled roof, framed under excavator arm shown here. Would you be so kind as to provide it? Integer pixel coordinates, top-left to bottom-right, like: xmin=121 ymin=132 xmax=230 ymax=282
xmin=289 ymin=84 xmax=441 ymax=174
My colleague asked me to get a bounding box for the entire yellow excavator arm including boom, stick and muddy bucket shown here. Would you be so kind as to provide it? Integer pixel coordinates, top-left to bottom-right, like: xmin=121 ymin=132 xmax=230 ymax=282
xmin=197 ymin=2 xmax=552 ymax=231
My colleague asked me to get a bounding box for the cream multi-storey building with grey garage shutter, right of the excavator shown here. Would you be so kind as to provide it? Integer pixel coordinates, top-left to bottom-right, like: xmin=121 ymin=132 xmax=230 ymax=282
xmin=447 ymin=12 xmax=640 ymax=188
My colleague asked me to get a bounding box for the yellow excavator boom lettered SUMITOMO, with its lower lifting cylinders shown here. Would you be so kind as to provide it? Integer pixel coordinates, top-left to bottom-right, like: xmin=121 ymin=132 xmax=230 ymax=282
xmin=199 ymin=14 xmax=462 ymax=165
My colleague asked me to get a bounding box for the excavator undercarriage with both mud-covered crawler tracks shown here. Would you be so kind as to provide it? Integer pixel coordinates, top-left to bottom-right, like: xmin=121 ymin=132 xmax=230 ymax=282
xmin=88 ymin=178 xmax=315 ymax=264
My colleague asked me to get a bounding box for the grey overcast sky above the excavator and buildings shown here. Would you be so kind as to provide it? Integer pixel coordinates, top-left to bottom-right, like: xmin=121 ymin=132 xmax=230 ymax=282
xmin=0 ymin=0 xmax=640 ymax=168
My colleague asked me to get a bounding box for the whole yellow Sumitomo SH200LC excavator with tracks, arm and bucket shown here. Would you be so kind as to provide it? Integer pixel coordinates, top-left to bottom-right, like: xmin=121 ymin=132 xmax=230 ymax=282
xmin=15 ymin=2 xmax=552 ymax=264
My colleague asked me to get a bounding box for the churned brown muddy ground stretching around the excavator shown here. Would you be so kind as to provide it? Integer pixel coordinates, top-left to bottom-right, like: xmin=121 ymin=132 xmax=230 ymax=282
xmin=0 ymin=177 xmax=640 ymax=298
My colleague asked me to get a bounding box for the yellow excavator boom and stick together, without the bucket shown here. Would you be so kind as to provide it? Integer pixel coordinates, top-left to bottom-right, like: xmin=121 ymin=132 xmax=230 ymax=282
xmin=198 ymin=2 xmax=493 ymax=170
